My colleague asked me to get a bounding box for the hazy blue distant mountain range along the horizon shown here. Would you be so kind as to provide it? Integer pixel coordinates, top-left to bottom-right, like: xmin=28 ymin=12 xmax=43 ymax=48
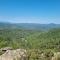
xmin=0 ymin=22 xmax=60 ymax=30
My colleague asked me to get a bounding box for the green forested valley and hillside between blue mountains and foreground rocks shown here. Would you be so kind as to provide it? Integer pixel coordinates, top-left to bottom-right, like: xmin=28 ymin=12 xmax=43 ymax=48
xmin=0 ymin=29 xmax=60 ymax=49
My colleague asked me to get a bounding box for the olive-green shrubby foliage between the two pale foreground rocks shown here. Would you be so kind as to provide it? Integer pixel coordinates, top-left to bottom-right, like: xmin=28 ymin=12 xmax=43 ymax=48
xmin=27 ymin=49 xmax=54 ymax=60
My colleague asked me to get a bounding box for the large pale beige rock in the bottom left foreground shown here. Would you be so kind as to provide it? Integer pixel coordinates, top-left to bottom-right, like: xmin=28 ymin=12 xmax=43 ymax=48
xmin=0 ymin=49 xmax=27 ymax=60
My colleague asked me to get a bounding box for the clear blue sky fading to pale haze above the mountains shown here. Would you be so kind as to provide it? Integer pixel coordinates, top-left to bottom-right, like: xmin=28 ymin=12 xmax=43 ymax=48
xmin=0 ymin=0 xmax=60 ymax=24
